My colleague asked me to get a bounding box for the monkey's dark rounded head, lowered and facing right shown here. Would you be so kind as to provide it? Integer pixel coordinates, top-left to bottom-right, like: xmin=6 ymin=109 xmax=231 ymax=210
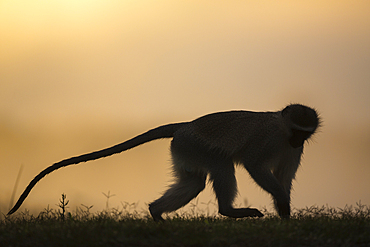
xmin=281 ymin=104 xmax=320 ymax=148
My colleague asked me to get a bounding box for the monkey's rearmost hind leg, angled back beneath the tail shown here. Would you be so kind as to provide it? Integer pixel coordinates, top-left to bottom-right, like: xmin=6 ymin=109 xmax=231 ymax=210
xmin=149 ymin=164 xmax=207 ymax=221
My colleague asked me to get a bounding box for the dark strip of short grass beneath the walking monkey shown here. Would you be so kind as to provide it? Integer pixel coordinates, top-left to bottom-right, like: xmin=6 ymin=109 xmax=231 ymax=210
xmin=0 ymin=195 xmax=370 ymax=246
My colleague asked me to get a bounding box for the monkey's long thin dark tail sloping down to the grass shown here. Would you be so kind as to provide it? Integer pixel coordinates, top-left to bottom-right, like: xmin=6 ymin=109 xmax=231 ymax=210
xmin=8 ymin=122 xmax=187 ymax=215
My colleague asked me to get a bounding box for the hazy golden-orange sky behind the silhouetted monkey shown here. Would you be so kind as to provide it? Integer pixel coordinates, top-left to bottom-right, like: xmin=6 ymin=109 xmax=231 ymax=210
xmin=0 ymin=0 xmax=370 ymax=216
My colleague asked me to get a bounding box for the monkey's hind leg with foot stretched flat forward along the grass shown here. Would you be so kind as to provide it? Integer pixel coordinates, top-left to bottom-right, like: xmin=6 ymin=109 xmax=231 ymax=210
xmin=210 ymin=161 xmax=263 ymax=218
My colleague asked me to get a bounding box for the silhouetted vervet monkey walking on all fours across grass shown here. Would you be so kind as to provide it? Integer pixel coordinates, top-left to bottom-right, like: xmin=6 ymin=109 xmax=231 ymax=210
xmin=8 ymin=104 xmax=320 ymax=221
